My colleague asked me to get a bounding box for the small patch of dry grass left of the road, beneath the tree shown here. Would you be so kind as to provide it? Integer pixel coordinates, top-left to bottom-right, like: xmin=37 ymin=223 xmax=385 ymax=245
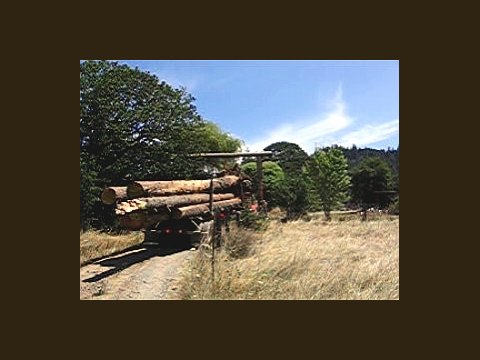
xmin=80 ymin=231 xmax=143 ymax=266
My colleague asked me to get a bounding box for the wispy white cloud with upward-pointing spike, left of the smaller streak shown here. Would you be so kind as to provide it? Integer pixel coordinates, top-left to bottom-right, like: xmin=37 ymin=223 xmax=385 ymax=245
xmin=246 ymin=86 xmax=353 ymax=153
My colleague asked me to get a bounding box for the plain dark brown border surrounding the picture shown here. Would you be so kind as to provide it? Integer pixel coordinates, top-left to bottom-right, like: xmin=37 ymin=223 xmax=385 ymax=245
xmin=6 ymin=3 xmax=476 ymax=358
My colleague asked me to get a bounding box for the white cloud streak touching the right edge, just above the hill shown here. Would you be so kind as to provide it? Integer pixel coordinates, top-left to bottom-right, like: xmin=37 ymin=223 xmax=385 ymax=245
xmin=335 ymin=119 xmax=399 ymax=146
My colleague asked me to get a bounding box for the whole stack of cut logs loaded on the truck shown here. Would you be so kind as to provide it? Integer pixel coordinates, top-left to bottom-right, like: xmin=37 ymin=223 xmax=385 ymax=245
xmin=101 ymin=175 xmax=248 ymax=230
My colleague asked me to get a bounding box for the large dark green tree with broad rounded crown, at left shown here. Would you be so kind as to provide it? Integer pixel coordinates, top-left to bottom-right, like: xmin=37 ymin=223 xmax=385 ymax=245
xmin=80 ymin=61 xmax=203 ymax=182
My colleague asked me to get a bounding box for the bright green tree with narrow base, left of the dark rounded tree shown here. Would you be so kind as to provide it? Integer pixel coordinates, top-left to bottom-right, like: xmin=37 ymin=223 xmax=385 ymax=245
xmin=309 ymin=148 xmax=350 ymax=219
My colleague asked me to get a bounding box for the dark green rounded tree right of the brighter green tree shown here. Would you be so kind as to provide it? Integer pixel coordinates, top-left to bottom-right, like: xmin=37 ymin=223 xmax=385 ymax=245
xmin=352 ymin=156 xmax=393 ymax=208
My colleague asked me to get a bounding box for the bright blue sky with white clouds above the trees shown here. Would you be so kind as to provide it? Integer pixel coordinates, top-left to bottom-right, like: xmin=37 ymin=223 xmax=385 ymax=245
xmin=117 ymin=60 xmax=399 ymax=153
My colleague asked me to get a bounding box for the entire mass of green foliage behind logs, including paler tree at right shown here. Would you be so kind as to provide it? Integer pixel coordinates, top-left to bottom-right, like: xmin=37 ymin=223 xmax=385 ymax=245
xmin=80 ymin=61 xmax=244 ymax=227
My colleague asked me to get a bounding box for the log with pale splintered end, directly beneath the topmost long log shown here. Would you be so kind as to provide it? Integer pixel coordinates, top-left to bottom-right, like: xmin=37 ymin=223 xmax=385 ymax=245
xmin=116 ymin=193 xmax=235 ymax=215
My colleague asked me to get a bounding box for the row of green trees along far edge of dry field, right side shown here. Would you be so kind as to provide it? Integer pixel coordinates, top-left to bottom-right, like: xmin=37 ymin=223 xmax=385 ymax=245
xmin=242 ymin=142 xmax=399 ymax=218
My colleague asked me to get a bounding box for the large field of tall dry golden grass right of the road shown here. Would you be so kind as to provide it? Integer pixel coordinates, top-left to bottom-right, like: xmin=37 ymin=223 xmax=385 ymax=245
xmin=180 ymin=217 xmax=399 ymax=300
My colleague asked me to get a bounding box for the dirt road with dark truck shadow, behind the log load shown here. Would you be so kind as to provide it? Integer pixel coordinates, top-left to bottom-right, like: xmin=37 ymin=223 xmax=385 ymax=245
xmin=80 ymin=246 xmax=194 ymax=300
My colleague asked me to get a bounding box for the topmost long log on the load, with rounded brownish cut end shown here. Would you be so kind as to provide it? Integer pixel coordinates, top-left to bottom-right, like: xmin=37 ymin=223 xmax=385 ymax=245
xmin=127 ymin=175 xmax=239 ymax=199
